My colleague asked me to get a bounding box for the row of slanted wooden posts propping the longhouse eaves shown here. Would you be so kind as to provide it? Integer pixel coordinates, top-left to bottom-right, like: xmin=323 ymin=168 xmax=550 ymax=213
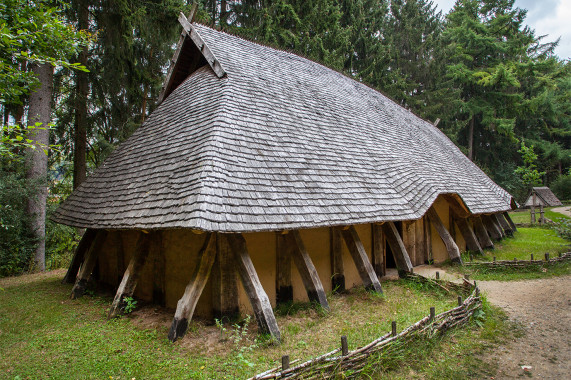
xmin=63 ymin=208 xmax=516 ymax=341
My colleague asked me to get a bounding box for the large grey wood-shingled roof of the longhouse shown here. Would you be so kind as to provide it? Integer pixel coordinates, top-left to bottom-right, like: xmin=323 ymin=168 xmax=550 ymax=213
xmin=53 ymin=24 xmax=512 ymax=232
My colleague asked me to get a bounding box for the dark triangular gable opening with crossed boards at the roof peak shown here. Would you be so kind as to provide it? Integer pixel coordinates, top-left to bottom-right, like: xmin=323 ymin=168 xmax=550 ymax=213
xmin=158 ymin=11 xmax=226 ymax=104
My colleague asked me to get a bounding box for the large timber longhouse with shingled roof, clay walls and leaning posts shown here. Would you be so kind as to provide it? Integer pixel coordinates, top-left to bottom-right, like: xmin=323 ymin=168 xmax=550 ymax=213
xmin=53 ymin=16 xmax=515 ymax=340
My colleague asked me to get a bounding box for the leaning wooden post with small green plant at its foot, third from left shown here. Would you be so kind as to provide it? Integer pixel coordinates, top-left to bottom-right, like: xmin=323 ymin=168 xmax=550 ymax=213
xmin=107 ymin=232 xmax=150 ymax=318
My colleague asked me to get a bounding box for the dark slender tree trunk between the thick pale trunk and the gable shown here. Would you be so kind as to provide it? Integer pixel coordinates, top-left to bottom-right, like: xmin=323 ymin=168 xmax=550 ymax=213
xmin=73 ymin=1 xmax=89 ymax=189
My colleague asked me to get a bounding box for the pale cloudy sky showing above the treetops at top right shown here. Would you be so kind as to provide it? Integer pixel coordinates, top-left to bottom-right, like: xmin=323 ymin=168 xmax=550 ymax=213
xmin=433 ymin=0 xmax=571 ymax=59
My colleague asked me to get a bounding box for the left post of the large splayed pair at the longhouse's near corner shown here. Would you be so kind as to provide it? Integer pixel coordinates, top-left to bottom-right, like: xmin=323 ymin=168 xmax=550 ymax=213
xmin=169 ymin=232 xmax=216 ymax=342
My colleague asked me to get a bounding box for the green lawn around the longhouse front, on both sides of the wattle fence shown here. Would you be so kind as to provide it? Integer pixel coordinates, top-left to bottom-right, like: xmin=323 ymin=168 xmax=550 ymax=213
xmin=0 ymin=271 xmax=509 ymax=379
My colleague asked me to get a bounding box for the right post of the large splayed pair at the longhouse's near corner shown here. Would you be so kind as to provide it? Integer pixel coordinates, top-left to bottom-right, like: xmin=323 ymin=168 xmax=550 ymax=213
xmin=228 ymin=234 xmax=280 ymax=342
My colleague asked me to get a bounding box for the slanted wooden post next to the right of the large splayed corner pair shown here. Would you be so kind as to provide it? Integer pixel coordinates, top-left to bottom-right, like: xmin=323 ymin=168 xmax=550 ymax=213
xmin=285 ymin=230 xmax=329 ymax=311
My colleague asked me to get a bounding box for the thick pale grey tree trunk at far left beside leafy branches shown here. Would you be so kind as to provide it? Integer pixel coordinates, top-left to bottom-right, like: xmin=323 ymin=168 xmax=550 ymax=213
xmin=26 ymin=64 xmax=54 ymax=271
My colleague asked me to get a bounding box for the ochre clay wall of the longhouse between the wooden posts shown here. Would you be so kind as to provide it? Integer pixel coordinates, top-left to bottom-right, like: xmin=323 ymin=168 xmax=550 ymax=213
xmin=98 ymin=198 xmax=465 ymax=318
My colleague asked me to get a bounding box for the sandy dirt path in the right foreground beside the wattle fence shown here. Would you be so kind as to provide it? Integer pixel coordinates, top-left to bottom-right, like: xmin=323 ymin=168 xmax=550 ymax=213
xmin=479 ymin=276 xmax=571 ymax=379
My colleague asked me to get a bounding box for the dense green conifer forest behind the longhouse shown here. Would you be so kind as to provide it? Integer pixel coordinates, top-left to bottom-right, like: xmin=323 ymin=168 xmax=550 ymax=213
xmin=0 ymin=0 xmax=571 ymax=276
